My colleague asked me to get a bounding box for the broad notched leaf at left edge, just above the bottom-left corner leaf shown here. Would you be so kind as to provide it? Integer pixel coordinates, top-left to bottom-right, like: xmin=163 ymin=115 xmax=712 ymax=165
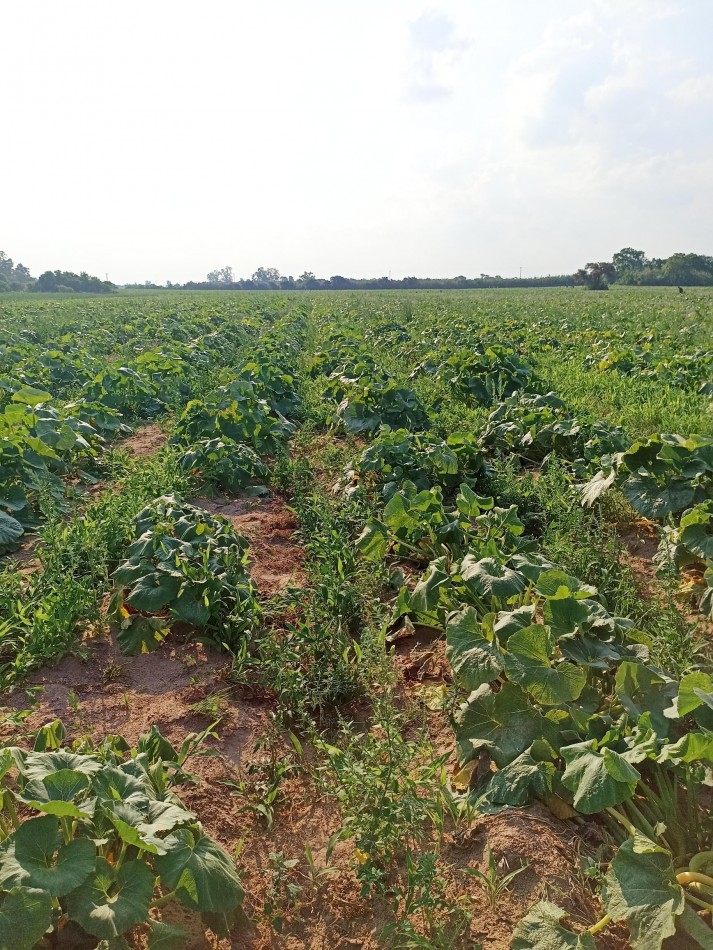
xmin=0 ymin=815 xmax=96 ymax=897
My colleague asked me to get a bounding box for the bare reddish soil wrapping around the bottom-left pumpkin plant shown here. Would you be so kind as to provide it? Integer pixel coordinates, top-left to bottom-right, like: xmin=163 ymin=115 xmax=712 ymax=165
xmin=0 ymin=634 xmax=378 ymax=950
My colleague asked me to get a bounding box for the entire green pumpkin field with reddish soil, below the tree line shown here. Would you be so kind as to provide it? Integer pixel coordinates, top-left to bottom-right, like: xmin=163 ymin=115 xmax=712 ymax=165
xmin=0 ymin=287 xmax=713 ymax=950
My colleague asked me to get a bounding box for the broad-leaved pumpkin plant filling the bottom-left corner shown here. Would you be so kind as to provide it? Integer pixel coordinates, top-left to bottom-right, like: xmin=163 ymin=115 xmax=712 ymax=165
xmin=0 ymin=721 xmax=244 ymax=950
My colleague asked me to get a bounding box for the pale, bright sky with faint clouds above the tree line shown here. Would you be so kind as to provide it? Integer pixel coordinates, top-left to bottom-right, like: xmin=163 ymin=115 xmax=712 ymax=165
xmin=0 ymin=0 xmax=713 ymax=283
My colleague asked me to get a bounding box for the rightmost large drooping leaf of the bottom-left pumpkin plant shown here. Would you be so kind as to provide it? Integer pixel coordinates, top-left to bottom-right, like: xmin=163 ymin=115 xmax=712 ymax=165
xmin=156 ymin=828 xmax=244 ymax=913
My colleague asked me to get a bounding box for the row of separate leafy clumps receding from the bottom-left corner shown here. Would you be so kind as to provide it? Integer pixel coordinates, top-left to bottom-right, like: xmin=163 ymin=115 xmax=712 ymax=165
xmin=0 ymin=311 xmax=303 ymax=950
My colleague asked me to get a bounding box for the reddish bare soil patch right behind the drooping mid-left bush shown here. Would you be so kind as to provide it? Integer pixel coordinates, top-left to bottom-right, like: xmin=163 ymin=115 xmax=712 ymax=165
xmin=192 ymin=495 xmax=305 ymax=597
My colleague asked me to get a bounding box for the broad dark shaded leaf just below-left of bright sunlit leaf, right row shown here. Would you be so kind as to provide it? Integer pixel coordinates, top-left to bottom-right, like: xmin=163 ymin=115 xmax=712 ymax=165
xmin=455 ymin=683 xmax=557 ymax=768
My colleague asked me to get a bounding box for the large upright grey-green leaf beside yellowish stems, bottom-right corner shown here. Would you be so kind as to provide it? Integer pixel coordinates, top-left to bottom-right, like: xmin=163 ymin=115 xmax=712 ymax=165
xmin=605 ymin=833 xmax=685 ymax=950
